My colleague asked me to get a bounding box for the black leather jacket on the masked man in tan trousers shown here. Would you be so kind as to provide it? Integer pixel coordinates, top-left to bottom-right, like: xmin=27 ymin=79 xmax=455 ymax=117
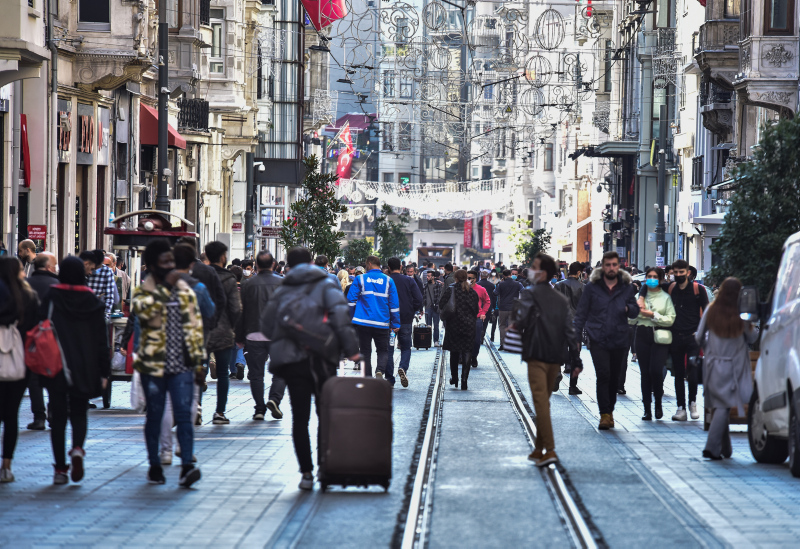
xmin=511 ymin=282 xmax=581 ymax=364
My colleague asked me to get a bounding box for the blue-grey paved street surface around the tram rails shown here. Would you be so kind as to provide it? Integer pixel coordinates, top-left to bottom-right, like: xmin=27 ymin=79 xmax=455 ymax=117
xmin=0 ymin=340 xmax=800 ymax=548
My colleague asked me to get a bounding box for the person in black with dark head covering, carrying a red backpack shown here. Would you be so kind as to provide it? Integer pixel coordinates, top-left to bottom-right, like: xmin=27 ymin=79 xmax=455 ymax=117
xmin=39 ymin=256 xmax=110 ymax=484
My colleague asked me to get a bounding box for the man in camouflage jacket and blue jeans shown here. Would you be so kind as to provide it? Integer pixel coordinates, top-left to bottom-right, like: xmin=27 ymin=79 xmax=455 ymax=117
xmin=131 ymin=238 xmax=205 ymax=488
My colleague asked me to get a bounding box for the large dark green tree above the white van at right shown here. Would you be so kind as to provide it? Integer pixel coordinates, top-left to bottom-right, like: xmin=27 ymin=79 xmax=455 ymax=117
xmin=709 ymin=118 xmax=800 ymax=297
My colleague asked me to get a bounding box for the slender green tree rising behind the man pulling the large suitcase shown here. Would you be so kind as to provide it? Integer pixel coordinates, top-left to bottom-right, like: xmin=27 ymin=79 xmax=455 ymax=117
xmin=279 ymin=155 xmax=347 ymax=262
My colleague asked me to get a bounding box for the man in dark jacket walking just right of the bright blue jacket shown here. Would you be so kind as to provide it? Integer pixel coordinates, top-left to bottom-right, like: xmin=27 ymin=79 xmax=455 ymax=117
xmin=386 ymin=257 xmax=422 ymax=387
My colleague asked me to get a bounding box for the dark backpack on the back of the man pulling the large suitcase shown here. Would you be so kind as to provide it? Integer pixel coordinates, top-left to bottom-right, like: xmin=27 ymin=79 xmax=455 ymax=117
xmin=278 ymin=280 xmax=339 ymax=362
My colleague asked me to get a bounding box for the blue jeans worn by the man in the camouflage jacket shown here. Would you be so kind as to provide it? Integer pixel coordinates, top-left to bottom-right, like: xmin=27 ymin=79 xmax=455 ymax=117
xmin=142 ymin=371 xmax=194 ymax=467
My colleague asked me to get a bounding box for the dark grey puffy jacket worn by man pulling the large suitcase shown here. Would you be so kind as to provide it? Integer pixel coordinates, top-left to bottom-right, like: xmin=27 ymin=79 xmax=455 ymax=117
xmin=261 ymin=264 xmax=359 ymax=375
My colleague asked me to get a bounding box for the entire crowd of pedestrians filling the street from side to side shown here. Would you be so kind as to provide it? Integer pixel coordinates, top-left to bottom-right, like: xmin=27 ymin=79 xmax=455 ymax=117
xmin=0 ymin=238 xmax=755 ymax=489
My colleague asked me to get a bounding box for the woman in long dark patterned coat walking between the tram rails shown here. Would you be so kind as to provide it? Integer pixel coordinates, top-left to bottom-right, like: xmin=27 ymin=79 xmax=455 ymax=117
xmin=439 ymin=270 xmax=479 ymax=391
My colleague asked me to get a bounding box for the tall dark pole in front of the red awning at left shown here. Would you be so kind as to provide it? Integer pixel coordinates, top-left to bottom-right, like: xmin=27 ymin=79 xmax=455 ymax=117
xmin=156 ymin=0 xmax=171 ymax=212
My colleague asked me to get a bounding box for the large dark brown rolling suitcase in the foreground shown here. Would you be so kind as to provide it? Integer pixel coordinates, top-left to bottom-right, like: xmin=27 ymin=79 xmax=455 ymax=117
xmin=318 ymin=362 xmax=393 ymax=492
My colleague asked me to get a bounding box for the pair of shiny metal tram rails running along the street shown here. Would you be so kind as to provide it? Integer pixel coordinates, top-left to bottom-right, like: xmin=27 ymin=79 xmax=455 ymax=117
xmin=393 ymin=341 xmax=606 ymax=549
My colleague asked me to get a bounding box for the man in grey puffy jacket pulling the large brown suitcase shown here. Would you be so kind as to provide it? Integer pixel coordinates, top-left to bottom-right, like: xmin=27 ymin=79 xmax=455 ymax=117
xmin=261 ymin=247 xmax=360 ymax=490
